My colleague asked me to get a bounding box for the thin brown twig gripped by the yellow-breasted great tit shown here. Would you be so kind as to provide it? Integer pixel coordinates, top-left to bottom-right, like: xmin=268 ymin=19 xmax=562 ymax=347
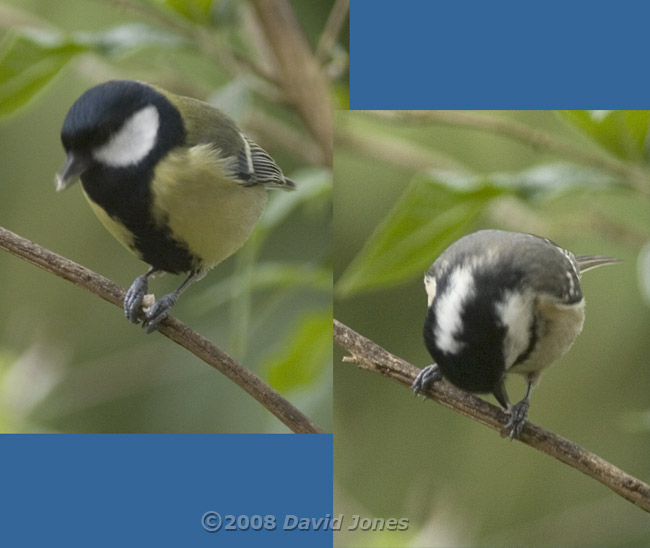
xmin=0 ymin=227 xmax=323 ymax=433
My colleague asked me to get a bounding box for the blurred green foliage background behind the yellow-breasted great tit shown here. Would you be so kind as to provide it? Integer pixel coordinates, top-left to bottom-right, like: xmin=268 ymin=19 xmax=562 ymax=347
xmin=0 ymin=0 xmax=348 ymax=432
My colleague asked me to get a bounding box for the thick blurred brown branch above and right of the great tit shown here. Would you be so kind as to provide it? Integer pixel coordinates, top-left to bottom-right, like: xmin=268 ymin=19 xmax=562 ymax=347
xmin=253 ymin=0 xmax=334 ymax=167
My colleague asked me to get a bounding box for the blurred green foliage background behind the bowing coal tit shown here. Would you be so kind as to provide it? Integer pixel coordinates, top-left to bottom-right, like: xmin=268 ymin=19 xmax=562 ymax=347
xmin=334 ymin=111 xmax=650 ymax=548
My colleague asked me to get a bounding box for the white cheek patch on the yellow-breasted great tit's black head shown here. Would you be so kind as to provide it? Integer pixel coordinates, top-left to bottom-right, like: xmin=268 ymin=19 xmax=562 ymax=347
xmin=93 ymin=105 xmax=160 ymax=167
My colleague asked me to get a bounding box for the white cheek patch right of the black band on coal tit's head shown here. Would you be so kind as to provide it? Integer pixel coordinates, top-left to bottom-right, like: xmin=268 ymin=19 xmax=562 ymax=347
xmin=494 ymin=291 xmax=534 ymax=369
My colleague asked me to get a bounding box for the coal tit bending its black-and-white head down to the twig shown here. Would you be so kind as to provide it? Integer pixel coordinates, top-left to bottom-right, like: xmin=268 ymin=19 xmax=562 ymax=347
xmin=413 ymin=230 xmax=620 ymax=439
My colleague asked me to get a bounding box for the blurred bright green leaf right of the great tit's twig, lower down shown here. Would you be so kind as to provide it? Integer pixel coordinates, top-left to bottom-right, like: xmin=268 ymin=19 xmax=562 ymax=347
xmin=266 ymin=310 xmax=332 ymax=393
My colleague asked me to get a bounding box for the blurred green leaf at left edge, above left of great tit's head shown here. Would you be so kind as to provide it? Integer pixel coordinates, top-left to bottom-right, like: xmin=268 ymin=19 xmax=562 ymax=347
xmin=0 ymin=31 xmax=88 ymax=117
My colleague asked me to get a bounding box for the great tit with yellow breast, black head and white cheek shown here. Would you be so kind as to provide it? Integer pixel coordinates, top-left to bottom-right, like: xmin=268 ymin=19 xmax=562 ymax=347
xmin=56 ymin=80 xmax=296 ymax=333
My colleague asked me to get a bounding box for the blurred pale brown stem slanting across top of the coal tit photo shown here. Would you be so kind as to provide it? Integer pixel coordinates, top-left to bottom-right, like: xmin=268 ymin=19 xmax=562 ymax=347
xmin=366 ymin=110 xmax=650 ymax=197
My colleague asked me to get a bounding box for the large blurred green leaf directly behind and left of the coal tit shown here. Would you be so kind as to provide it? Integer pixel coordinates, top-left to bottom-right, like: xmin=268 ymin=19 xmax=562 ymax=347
xmin=335 ymin=173 xmax=503 ymax=297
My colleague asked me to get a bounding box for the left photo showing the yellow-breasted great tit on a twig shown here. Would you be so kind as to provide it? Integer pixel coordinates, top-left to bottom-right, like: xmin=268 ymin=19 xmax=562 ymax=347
xmin=0 ymin=0 xmax=348 ymax=433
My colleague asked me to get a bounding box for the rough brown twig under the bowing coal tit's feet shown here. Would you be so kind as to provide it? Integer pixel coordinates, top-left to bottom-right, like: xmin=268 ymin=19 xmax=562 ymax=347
xmin=334 ymin=320 xmax=650 ymax=512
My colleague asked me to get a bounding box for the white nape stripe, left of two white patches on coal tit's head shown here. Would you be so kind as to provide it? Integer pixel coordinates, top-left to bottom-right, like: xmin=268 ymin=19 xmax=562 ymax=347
xmin=434 ymin=265 xmax=476 ymax=354
